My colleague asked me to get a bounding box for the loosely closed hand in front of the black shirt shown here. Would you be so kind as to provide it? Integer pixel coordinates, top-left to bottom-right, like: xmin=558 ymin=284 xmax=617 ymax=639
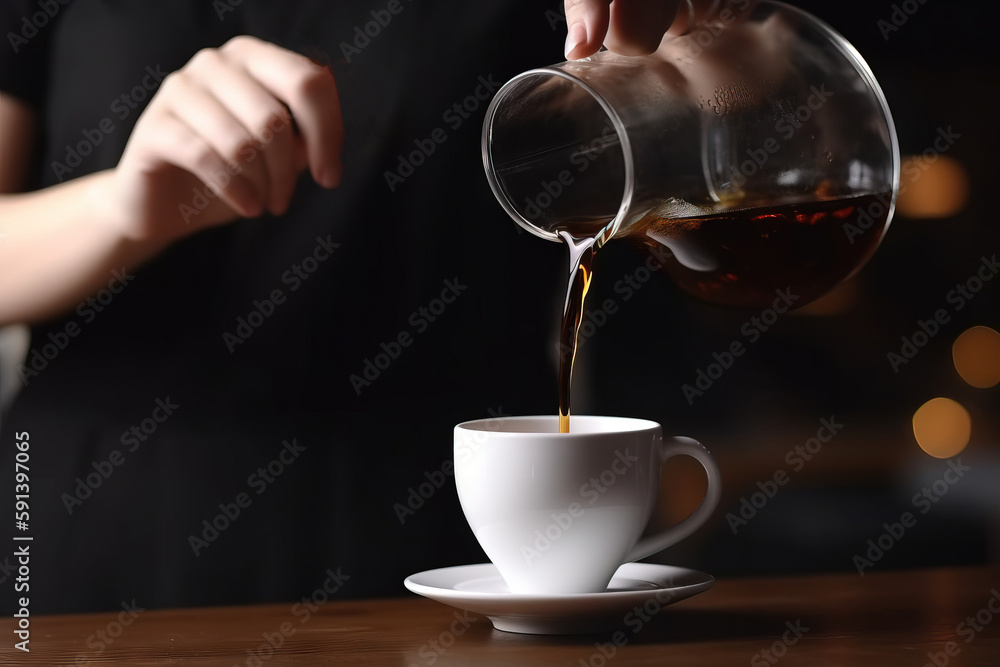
xmin=108 ymin=36 xmax=344 ymax=241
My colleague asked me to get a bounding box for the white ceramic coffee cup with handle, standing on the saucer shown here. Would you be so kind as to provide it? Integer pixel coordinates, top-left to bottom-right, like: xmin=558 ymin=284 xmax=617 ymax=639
xmin=455 ymin=415 xmax=720 ymax=595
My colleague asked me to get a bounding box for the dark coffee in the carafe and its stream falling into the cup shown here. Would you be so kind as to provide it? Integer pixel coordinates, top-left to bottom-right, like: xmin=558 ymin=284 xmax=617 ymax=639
xmin=558 ymin=193 xmax=890 ymax=433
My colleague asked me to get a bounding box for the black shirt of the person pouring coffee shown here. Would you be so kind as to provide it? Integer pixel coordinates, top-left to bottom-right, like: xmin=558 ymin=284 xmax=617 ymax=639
xmin=0 ymin=0 xmax=565 ymax=613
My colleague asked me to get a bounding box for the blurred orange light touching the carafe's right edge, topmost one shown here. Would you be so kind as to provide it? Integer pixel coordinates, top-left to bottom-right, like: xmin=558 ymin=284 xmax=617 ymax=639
xmin=896 ymin=155 xmax=969 ymax=218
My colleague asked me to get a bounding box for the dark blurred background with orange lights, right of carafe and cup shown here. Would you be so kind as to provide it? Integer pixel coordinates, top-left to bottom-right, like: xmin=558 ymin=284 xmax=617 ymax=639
xmin=577 ymin=1 xmax=1000 ymax=574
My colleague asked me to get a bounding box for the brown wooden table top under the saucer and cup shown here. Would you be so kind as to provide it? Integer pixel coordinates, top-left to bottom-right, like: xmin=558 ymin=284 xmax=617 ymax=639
xmin=0 ymin=568 xmax=1000 ymax=667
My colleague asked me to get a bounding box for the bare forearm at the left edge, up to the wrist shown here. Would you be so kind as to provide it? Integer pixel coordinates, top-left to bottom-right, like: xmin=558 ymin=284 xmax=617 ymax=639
xmin=0 ymin=171 xmax=166 ymax=325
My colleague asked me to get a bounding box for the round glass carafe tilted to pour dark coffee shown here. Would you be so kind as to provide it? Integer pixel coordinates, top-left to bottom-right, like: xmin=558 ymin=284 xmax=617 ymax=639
xmin=482 ymin=2 xmax=899 ymax=306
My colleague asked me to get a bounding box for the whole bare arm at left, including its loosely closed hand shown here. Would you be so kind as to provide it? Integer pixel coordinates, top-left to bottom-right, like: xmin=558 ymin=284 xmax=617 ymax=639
xmin=0 ymin=36 xmax=344 ymax=325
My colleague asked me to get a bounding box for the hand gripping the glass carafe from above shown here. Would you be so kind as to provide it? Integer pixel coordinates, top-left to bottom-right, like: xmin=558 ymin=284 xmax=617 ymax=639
xmin=565 ymin=0 xmax=750 ymax=60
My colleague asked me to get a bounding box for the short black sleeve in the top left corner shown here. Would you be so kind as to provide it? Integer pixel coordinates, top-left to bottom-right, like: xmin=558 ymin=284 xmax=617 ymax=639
xmin=0 ymin=0 xmax=56 ymax=106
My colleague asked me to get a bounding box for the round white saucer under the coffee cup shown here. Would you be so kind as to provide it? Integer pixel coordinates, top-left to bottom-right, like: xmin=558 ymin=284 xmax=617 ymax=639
xmin=403 ymin=563 xmax=715 ymax=635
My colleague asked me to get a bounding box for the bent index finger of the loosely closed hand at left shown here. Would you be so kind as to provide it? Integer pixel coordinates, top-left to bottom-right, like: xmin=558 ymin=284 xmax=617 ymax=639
xmin=221 ymin=37 xmax=344 ymax=187
